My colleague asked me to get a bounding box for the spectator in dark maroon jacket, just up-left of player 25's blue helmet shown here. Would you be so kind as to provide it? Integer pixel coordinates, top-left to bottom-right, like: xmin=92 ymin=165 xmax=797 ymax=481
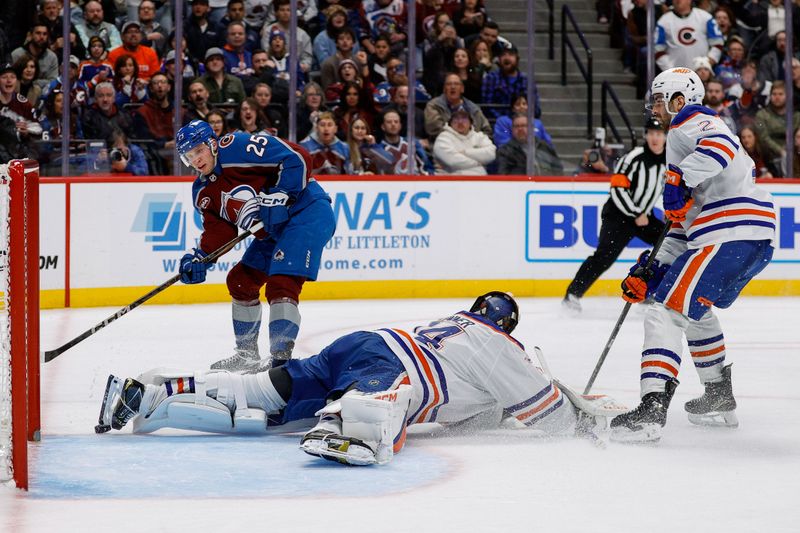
xmin=133 ymin=72 xmax=175 ymax=153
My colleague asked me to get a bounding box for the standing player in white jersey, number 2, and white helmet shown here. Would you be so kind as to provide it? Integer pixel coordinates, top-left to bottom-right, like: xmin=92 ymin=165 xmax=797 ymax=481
xmin=611 ymin=68 xmax=775 ymax=441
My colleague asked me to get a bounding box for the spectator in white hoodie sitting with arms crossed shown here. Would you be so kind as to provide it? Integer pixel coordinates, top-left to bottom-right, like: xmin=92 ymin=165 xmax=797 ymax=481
xmin=433 ymin=108 xmax=496 ymax=176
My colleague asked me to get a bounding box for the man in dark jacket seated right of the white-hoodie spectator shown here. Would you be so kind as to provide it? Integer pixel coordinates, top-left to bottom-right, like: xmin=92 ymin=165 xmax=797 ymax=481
xmin=497 ymin=115 xmax=564 ymax=176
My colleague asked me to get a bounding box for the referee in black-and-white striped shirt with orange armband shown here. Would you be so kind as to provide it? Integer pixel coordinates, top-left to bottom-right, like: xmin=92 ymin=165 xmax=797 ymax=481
xmin=562 ymin=117 xmax=667 ymax=312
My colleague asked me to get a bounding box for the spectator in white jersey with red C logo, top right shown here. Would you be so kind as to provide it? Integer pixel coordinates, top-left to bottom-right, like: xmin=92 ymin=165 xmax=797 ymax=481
xmin=655 ymin=0 xmax=725 ymax=70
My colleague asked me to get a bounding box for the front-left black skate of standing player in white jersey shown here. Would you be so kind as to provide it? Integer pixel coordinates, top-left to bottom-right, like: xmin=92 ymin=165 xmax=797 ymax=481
xmin=611 ymin=379 xmax=678 ymax=443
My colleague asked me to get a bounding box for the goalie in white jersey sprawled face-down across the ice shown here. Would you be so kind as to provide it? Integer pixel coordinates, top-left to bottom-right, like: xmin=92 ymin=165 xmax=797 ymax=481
xmin=96 ymin=292 xmax=624 ymax=465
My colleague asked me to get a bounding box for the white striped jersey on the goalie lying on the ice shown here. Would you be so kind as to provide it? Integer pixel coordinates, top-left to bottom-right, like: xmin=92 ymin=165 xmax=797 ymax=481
xmin=376 ymin=312 xmax=576 ymax=434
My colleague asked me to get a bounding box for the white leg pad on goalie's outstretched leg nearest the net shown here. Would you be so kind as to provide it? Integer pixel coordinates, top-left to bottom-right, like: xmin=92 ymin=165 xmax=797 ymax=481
xmin=133 ymin=369 xmax=267 ymax=433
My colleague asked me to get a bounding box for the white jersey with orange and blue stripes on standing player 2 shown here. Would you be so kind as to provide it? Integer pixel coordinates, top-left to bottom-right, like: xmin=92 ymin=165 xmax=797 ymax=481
xmin=659 ymin=105 xmax=776 ymax=254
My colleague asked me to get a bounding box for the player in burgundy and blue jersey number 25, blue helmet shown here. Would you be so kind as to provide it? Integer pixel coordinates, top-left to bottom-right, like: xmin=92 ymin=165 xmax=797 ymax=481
xmin=176 ymin=120 xmax=335 ymax=371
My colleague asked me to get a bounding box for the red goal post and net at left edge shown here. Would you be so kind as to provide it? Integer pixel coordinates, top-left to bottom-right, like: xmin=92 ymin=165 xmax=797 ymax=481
xmin=0 ymin=160 xmax=40 ymax=490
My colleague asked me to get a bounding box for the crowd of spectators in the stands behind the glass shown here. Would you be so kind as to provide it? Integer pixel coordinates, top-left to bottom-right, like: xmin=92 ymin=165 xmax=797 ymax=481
xmin=0 ymin=0 xmax=800 ymax=176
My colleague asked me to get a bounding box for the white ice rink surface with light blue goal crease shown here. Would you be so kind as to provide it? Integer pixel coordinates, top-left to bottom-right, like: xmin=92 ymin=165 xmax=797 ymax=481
xmin=0 ymin=298 xmax=800 ymax=533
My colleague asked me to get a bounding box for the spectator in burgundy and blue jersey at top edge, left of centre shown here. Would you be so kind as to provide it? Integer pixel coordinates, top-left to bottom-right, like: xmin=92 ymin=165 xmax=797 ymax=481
xmin=358 ymin=0 xmax=408 ymax=54
